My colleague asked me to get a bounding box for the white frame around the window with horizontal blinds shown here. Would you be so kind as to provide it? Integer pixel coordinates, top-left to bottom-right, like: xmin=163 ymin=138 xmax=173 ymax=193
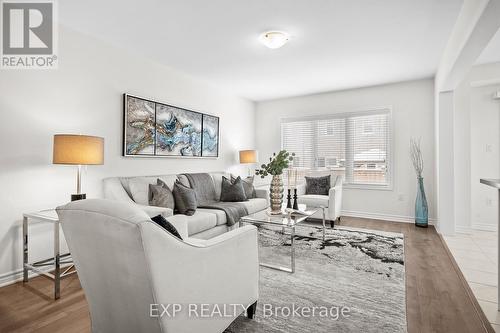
xmin=280 ymin=105 xmax=395 ymax=191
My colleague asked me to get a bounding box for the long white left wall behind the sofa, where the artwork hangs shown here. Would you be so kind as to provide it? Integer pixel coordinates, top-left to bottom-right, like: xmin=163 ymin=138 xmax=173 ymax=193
xmin=0 ymin=28 xmax=255 ymax=284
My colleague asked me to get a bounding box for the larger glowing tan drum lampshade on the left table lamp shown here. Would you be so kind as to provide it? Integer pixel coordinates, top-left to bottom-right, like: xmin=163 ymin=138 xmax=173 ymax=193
xmin=52 ymin=134 xmax=104 ymax=165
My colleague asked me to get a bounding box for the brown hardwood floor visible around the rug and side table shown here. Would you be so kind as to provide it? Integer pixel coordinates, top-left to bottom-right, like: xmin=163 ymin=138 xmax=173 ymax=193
xmin=0 ymin=218 xmax=494 ymax=333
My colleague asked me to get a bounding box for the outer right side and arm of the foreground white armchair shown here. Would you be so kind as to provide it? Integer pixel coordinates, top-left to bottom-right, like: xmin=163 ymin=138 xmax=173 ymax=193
xmin=140 ymin=223 xmax=259 ymax=332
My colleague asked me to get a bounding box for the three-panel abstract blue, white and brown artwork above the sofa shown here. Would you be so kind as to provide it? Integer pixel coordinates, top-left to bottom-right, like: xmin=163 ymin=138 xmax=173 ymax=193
xmin=123 ymin=94 xmax=219 ymax=157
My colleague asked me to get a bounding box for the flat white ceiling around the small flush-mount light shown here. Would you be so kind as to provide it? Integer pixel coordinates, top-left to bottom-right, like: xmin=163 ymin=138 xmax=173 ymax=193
xmin=59 ymin=0 xmax=462 ymax=101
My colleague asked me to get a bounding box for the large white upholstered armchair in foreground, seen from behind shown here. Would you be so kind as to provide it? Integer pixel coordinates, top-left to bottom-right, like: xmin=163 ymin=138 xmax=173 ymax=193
xmin=57 ymin=199 xmax=259 ymax=333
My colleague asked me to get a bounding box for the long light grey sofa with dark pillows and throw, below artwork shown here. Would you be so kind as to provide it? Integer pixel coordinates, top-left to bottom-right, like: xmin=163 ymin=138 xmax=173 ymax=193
xmin=103 ymin=172 xmax=269 ymax=239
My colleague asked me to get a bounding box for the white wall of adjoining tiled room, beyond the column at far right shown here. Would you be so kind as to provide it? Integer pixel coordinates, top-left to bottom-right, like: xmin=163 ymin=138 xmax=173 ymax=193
xmin=454 ymin=63 xmax=500 ymax=231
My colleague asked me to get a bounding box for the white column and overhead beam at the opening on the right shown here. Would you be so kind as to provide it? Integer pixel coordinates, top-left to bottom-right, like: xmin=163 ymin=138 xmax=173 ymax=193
xmin=434 ymin=0 xmax=500 ymax=234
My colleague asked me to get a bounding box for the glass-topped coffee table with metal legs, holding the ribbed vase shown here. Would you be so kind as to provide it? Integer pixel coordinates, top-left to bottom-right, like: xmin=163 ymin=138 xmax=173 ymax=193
xmin=240 ymin=205 xmax=326 ymax=273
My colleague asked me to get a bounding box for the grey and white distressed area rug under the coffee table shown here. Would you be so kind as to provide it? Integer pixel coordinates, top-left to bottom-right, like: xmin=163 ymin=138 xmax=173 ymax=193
xmin=226 ymin=226 xmax=406 ymax=333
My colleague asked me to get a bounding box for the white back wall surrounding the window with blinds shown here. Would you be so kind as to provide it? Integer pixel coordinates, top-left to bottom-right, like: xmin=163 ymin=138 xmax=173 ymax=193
xmin=256 ymin=79 xmax=435 ymax=221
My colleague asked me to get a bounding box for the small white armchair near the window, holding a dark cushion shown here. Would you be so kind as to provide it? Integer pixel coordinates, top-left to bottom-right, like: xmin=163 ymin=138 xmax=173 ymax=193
xmin=297 ymin=176 xmax=343 ymax=228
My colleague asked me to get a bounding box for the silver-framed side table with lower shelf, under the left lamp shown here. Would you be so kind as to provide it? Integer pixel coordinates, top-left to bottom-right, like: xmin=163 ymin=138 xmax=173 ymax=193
xmin=23 ymin=209 xmax=76 ymax=299
